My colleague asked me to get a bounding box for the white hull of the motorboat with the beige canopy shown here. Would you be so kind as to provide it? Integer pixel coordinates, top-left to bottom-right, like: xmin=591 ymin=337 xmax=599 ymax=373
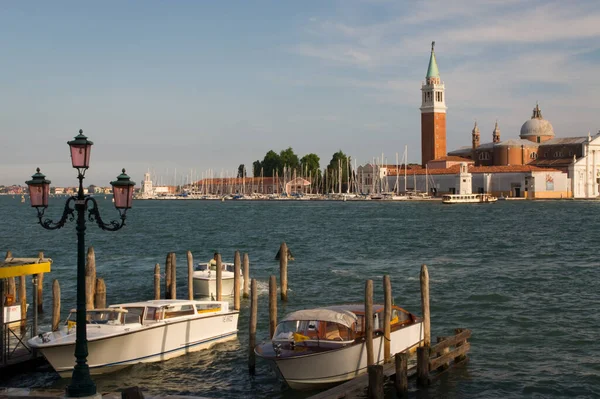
xmin=257 ymin=322 xmax=423 ymax=390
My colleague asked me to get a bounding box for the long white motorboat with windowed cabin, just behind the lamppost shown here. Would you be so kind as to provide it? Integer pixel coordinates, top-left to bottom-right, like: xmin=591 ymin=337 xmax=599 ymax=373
xmin=28 ymin=299 xmax=239 ymax=377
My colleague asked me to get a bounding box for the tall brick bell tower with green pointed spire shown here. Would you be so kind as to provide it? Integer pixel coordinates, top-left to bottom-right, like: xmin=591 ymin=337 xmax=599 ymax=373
xmin=421 ymin=42 xmax=446 ymax=167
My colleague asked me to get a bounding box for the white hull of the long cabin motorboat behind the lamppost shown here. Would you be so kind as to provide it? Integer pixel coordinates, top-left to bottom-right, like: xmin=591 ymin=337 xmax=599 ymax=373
xmin=37 ymin=312 xmax=238 ymax=377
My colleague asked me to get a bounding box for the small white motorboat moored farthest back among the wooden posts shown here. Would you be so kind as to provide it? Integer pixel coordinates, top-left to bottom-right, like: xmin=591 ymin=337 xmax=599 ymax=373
xmin=192 ymin=260 xmax=244 ymax=299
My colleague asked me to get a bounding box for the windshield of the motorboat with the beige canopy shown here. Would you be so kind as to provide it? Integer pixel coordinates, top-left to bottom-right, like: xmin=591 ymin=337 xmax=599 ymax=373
xmin=273 ymin=320 xmax=355 ymax=343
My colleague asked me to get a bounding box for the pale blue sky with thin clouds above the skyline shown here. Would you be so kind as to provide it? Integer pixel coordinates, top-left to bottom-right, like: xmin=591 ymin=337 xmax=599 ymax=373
xmin=0 ymin=0 xmax=600 ymax=186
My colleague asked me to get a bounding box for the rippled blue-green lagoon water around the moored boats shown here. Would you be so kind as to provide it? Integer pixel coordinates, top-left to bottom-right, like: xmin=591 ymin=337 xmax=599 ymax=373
xmin=0 ymin=196 xmax=600 ymax=398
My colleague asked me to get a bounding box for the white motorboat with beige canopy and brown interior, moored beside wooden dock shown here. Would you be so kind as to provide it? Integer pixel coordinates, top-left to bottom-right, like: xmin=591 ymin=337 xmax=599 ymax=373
xmin=254 ymin=304 xmax=423 ymax=390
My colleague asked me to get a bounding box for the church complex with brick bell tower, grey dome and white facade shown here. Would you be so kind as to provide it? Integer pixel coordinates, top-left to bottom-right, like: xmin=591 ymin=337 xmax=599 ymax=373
xmin=418 ymin=42 xmax=600 ymax=198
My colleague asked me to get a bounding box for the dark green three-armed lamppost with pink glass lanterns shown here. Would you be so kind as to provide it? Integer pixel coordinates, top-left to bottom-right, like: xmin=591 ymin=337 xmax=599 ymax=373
xmin=25 ymin=130 xmax=135 ymax=397
